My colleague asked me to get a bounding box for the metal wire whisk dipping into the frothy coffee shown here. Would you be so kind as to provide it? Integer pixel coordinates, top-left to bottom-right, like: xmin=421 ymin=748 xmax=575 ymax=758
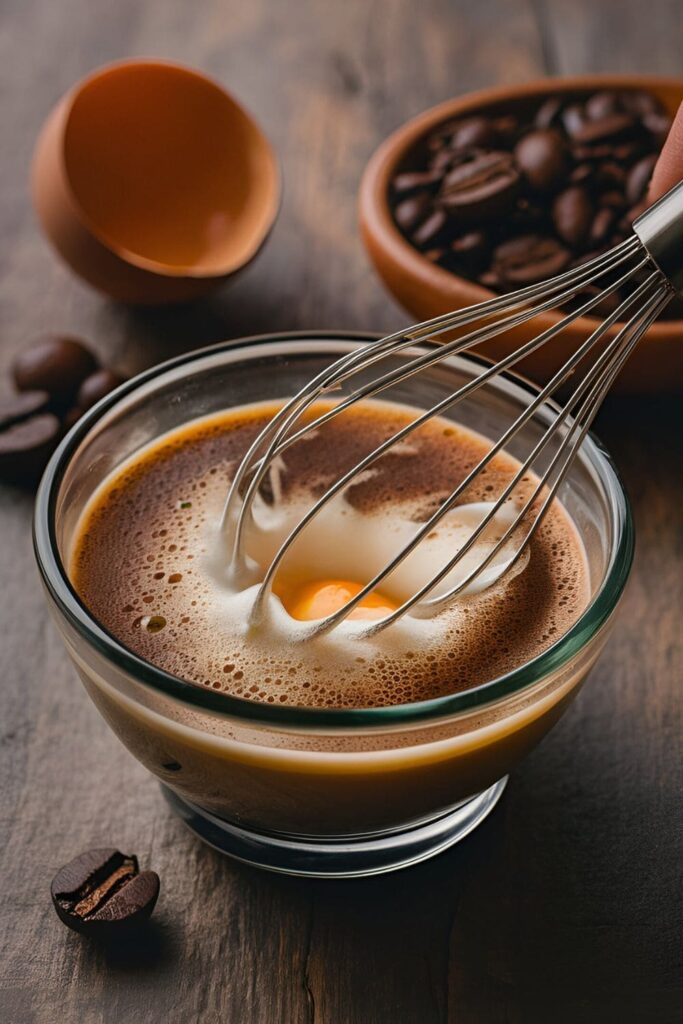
xmin=223 ymin=182 xmax=683 ymax=636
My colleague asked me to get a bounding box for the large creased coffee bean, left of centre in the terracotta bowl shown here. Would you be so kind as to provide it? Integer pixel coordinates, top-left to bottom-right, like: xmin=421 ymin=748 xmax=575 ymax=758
xmin=439 ymin=152 xmax=519 ymax=221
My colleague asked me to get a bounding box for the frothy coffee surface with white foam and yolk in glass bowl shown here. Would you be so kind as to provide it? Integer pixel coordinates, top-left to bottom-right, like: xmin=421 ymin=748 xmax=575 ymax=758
xmin=70 ymin=402 xmax=589 ymax=708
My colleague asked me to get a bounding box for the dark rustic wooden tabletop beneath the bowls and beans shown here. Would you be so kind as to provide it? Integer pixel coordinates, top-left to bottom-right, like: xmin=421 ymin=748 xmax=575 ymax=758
xmin=0 ymin=0 xmax=683 ymax=1024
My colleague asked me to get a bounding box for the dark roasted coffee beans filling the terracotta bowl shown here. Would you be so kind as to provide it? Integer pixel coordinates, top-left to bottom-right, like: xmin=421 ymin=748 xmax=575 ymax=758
xmin=389 ymin=90 xmax=680 ymax=315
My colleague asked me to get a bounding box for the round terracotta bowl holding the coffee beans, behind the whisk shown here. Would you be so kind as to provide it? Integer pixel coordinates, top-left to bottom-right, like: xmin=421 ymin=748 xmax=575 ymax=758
xmin=359 ymin=75 xmax=683 ymax=392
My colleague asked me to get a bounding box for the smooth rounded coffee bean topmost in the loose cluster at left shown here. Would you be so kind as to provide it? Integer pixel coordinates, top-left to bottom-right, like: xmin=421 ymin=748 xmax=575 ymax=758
xmin=12 ymin=335 xmax=97 ymax=404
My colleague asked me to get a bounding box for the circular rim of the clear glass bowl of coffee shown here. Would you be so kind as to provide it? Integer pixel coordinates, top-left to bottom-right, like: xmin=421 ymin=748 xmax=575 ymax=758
xmin=33 ymin=331 xmax=635 ymax=730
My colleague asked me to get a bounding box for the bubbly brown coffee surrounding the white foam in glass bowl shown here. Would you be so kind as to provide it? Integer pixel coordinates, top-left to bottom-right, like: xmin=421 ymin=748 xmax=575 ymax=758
xmin=71 ymin=403 xmax=589 ymax=708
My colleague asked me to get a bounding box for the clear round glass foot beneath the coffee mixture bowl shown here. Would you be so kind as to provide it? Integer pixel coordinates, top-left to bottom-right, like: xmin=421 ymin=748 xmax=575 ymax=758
xmin=162 ymin=775 xmax=508 ymax=879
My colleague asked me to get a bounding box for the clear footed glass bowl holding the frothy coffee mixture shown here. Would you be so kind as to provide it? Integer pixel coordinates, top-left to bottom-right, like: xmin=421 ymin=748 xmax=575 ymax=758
xmin=34 ymin=332 xmax=633 ymax=877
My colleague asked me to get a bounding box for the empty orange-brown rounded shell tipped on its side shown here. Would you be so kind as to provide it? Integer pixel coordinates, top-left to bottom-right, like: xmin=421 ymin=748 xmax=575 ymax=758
xmin=32 ymin=59 xmax=280 ymax=304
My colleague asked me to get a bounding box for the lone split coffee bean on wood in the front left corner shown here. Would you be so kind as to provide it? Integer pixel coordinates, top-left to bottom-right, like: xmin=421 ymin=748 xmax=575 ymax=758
xmin=50 ymin=848 xmax=159 ymax=938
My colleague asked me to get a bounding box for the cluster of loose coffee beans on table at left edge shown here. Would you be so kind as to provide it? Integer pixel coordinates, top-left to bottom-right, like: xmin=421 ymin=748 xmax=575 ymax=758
xmin=0 ymin=335 xmax=124 ymax=484
